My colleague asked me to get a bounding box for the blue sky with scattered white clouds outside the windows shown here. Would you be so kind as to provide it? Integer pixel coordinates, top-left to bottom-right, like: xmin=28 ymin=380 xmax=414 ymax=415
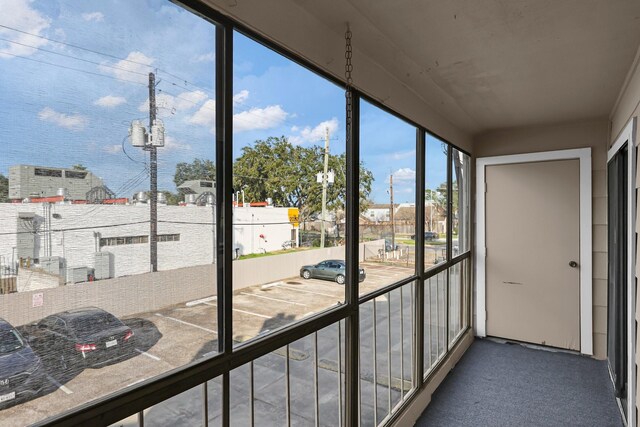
xmin=0 ymin=0 xmax=446 ymax=203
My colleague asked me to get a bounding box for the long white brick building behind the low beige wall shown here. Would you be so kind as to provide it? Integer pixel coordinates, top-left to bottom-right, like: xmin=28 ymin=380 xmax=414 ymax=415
xmin=0 ymin=203 xmax=298 ymax=277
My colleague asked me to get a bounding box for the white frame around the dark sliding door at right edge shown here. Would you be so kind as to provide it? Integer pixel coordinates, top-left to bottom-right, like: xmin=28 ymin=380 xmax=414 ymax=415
xmin=607 ymin=117 xmax=637 ymax=427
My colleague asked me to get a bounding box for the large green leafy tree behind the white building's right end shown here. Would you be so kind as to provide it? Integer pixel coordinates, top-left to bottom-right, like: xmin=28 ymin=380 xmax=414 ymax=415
xmin=234 ymin=136 xmax=373 ymax=221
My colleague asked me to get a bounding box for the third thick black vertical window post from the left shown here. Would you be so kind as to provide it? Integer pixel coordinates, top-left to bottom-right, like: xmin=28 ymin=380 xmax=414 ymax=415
xmin=416 ymin=128 xmax=426 ymax=386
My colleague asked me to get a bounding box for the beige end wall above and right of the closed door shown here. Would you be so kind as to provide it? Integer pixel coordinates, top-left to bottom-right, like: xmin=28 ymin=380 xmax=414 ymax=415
xmin=473 ymin=119 xmax=609 ymax=359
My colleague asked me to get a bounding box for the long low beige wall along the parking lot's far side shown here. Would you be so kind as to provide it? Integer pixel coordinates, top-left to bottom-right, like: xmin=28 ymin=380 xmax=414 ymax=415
xmin=0 ymin=244 xmax=384 ymax=326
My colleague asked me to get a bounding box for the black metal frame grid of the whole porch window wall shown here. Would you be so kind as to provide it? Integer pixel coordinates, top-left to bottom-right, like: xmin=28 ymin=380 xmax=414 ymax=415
xmin=37 ymin=0 xmax=474 ymax=426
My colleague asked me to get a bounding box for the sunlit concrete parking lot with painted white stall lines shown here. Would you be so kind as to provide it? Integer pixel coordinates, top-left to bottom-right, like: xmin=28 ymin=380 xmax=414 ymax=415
xmin=0 ymin=263 xmax=422 ymax=425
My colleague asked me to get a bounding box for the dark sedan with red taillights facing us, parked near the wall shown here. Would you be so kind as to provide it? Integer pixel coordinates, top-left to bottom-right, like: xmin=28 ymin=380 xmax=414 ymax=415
xmin=30 ymin=307 xmax=133 ymax=372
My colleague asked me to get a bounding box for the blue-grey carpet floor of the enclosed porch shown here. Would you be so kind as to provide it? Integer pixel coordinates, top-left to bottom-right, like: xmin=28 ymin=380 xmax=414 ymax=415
xmin=416 ymin=340 xmax=623 ymax=427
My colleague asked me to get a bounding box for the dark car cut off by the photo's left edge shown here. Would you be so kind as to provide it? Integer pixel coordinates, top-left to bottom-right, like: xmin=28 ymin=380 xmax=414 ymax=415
xmin=0 ymin=319 xmax=46 ymax=408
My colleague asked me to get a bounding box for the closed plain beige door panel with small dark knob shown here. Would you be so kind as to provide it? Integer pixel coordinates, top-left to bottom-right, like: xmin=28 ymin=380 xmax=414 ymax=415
xmin=485 ymin=159 xmax=580 ymax=350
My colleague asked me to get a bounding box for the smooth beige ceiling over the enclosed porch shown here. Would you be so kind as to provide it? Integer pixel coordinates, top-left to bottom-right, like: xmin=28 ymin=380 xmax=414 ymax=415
xmin=294 ymin=0 xmax=640 ymax=134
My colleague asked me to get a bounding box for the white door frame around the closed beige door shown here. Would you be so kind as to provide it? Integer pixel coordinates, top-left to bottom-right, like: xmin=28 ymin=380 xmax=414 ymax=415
xmin=475 ymin=148 xmax=593 ymax=356
